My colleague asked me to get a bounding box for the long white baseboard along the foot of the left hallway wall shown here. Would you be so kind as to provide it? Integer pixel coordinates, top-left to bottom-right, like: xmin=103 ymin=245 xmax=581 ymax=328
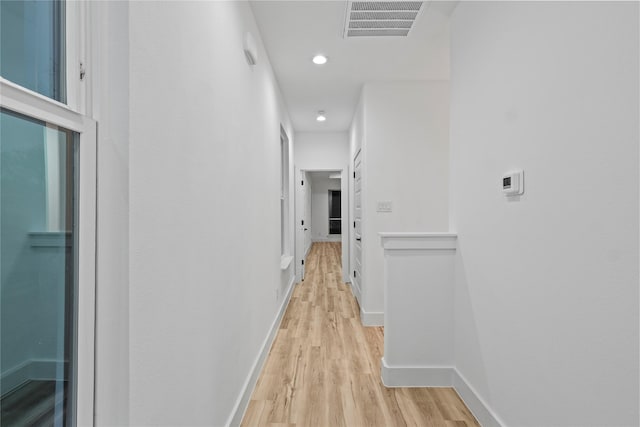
xmin=225 ymin=276 xmax=296 ymax=427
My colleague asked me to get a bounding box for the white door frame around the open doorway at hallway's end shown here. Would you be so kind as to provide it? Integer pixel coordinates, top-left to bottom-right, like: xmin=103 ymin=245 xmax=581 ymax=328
xmin=294 ymin=165 xmax=351 ymax=283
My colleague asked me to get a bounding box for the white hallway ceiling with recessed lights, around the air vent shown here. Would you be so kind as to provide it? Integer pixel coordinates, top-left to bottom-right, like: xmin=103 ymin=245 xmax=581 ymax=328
xmin=250 ymin=0 xmax=457 ymax=132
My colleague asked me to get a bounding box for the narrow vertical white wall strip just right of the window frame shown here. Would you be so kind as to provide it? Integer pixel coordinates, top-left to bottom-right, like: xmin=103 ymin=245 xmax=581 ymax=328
xmin=87 ymin=1 xmax=129 ymax=426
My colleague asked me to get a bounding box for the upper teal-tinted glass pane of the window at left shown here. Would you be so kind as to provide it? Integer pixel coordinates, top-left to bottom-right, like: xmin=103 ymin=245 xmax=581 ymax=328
xmin=0 ymin=0 xmax=67 ymax=103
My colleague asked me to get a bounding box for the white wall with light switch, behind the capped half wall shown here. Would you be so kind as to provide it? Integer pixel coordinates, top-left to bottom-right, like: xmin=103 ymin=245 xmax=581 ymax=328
xmin=351 ymin=81 xmax=449 ymax=324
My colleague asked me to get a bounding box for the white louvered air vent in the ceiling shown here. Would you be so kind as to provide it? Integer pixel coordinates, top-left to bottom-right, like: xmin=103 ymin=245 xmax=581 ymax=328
xmin=344 ymin=0 xmax=424 ymax=37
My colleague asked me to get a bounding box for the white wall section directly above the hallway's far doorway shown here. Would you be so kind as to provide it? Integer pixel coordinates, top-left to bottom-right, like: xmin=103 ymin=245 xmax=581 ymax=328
xmin=295 ymin=132 xmax=349 ymax=170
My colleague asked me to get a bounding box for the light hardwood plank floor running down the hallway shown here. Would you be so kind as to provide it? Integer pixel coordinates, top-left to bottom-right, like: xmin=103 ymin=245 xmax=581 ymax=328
xmin=242 ymin=243 xmax=479 ymax=427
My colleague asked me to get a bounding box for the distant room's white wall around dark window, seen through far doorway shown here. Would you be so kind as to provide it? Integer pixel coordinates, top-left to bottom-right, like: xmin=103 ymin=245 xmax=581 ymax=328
xmin=309 ymin=172 xmax=342 ymax=242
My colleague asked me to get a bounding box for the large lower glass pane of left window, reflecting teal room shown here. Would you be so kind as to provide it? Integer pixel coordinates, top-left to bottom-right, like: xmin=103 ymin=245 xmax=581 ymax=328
xmin=0 ymin=109 xmax=78 ymax=426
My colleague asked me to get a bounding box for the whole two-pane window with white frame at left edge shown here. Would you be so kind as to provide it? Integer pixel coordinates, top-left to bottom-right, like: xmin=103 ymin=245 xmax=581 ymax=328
xmin=0 ymin=0 xmax=96 ymax=426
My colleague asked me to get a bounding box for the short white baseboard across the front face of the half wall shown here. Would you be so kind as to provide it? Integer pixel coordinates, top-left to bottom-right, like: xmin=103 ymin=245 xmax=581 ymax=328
xmin=381 ymin=357 xmax=453 ymax=387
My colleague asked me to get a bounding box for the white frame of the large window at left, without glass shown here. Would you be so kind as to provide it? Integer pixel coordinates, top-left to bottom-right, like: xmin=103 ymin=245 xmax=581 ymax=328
xmin=0 ymin=1 xmax=97 ymax=426
